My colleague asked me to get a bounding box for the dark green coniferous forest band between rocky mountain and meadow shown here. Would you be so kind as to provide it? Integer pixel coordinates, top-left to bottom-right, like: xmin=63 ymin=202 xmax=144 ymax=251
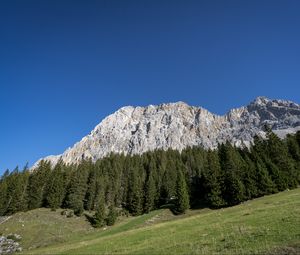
xmin=0 ymin=130 xmax=300 ymax=227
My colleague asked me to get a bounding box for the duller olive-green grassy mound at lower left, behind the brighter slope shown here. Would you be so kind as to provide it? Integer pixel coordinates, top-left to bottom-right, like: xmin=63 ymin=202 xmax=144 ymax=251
xmin=0 ymin=208 xmax=94 ymax=249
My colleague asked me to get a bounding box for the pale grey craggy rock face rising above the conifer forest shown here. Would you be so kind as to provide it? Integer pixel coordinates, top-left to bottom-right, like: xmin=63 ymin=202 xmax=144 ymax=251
xmin=36 ymin=97 xmax=300 ymax=164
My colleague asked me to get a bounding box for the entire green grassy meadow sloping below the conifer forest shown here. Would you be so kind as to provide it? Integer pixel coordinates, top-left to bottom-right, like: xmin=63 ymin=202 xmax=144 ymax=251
xmin=0 ymin=188 xmax=300 ymax=254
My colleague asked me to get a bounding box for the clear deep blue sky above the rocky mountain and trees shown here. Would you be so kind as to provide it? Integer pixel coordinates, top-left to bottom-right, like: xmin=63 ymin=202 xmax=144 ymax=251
xmin=0 ymin=0 xmax=300 ymax=173
